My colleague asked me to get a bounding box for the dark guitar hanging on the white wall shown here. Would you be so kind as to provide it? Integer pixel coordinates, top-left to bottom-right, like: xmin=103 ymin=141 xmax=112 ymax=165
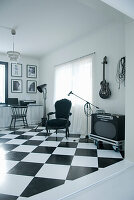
xmin=99 ymin=56 xmax=111 ymax=99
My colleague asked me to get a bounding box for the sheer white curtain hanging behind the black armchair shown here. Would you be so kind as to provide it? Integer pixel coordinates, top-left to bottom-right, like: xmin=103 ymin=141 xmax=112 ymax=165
xmin=54 ymin=56 xmax=92 ymax=134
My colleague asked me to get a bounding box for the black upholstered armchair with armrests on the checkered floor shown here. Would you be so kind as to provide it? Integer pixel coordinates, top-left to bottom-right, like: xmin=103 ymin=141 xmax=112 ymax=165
xmin=46 ymin=99 xmax=72 ymax=138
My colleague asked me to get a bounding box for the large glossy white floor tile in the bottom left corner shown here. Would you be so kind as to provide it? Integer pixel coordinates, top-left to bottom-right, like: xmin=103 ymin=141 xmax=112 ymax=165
xmin=0 ymin=174 xmax=33 ymax=196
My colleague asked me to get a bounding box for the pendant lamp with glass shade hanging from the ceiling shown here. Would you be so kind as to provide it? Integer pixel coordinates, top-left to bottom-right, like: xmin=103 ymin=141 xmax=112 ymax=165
xmin=7 ymin=29 xmax=20 ymax=62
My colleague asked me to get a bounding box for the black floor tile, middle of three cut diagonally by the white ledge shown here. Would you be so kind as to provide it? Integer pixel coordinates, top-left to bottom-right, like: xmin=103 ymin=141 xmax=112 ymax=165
xmin=66 ymin=166 xmax=98 ymax=180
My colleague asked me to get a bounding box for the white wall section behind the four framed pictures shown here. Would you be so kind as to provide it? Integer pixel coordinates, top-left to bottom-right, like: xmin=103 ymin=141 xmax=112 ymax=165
xmin=0 ymin=54 xmax=39 ymax=103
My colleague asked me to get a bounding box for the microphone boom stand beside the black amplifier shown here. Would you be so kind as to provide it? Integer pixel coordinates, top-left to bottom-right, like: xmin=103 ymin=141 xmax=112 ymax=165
xmin=68 ymin=91 xmax=99 ymax=139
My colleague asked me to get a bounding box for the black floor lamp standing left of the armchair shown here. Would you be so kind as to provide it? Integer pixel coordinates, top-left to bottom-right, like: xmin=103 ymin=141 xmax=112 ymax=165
xmin=37 ymin=84 xmax=47 ymax=126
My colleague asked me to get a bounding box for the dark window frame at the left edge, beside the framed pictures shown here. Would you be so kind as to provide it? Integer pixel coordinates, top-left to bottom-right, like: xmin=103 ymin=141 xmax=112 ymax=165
xmin=0 ymin=61 xmax=8 ymax=105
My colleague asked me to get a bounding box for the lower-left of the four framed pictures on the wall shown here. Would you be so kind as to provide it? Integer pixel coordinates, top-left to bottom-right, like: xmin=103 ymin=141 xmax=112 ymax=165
xmin=11 ymin=79 xmax=22 ymax=93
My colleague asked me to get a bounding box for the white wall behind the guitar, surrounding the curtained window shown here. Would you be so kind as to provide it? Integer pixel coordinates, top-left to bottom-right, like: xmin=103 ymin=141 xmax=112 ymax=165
xmin=40 ymin=24 xmax=125 ymax=114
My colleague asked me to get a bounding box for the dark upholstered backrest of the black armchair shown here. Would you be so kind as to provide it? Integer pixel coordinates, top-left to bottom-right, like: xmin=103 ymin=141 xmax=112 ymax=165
xmin=55 ymin=99 xmax=72 ymax=119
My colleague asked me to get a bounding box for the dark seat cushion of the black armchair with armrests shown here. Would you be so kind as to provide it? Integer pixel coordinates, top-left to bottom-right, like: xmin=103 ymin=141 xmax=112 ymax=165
xmin=47 ymin=118 xmax=70 ymax=128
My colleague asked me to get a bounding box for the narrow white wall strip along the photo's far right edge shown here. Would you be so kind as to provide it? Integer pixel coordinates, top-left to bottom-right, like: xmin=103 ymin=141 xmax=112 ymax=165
xmin=125 ymin=22 xmax=134 ymax=161
